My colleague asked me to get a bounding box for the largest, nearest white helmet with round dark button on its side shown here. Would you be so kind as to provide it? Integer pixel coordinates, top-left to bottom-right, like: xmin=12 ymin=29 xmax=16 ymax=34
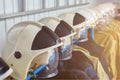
xmin=2 ymin=21 xmax=61 ymax=80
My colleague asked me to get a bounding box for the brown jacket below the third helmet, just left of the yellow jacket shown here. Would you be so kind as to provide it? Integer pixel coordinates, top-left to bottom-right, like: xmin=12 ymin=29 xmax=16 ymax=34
xmin=76 ymin=29 xmax=112 ymax=80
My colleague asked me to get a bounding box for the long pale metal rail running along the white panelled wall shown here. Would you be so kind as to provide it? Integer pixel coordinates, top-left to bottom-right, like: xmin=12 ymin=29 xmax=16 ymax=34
xmin=0 ymin=0 xmax=89 ymax=20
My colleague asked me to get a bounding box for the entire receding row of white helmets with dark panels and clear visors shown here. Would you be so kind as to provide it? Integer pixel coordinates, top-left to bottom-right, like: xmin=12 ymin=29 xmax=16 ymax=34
xmin=0 ymin=3 xmax=117 ymax=80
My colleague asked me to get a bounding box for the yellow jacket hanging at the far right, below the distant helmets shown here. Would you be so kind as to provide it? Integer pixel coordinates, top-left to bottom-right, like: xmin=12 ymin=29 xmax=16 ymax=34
xmin=95 ymin=19 xmax=120 ymax=80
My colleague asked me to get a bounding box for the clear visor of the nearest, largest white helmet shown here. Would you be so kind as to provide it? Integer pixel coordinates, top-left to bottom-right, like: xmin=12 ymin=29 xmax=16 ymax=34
xmin=28 ymin=48 xmax=59 ymax=78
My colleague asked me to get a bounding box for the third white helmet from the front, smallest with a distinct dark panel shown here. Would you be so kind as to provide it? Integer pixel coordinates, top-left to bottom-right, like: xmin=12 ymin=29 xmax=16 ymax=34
xmin=58 ymin=12 xmax=88 ymax=41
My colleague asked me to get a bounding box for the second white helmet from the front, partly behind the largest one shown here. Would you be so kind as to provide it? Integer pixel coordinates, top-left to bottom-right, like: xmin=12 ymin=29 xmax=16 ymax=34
xmin=39 ymin=17 xmax=75 ymax=60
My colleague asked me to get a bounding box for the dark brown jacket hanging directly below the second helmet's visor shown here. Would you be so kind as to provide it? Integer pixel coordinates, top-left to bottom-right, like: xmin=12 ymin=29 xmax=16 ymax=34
xmin=59 ymin=51 xmax=99 ymax=80
